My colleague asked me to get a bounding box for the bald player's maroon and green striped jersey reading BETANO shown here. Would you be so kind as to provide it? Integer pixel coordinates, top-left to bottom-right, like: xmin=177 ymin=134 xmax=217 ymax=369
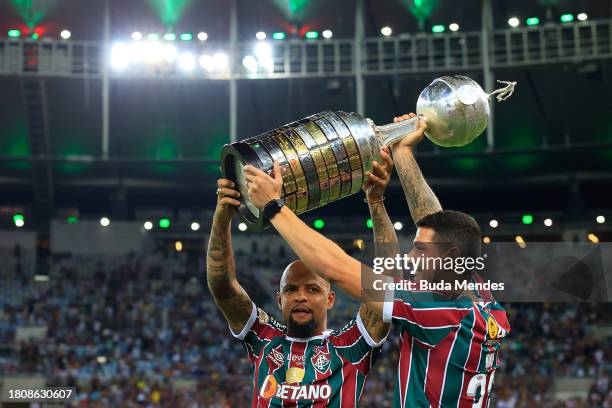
xmin=232 ymin=304 xmax=384 ymax=408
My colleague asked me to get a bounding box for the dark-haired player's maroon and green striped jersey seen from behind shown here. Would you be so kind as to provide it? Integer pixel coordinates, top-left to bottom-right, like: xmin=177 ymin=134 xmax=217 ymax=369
xmin=383 ymin=290 xmax=510 ymax=408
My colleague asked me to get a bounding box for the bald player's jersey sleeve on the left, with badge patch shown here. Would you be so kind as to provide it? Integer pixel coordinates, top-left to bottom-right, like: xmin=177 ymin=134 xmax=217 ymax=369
xmin=230 ymin=303 xmax=285 ymax=360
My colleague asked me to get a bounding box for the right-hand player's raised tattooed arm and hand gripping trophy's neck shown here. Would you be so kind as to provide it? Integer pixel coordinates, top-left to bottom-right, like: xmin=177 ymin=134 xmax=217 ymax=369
xmin=392 ymin=113 xmax=442 ymax=223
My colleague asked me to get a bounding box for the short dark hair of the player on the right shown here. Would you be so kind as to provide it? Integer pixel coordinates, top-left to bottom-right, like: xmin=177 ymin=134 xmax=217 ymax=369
xmin=416 ymin=210 xmax=481 ymax=258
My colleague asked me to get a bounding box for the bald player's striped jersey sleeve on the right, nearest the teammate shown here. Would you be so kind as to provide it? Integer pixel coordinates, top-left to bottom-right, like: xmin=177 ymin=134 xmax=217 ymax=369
xmin=329 ymin=312 xmax=387 ymax=375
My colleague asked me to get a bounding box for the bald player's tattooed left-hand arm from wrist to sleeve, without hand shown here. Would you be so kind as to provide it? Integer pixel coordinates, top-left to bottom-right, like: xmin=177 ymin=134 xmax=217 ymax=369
xmin=206 ymin=217 xmax=252 ymax=332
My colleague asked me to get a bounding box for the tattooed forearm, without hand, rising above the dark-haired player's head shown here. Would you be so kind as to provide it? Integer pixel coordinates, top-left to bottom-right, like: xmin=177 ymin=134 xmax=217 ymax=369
xmin=395 ymin=150 xmax=442 ymax=223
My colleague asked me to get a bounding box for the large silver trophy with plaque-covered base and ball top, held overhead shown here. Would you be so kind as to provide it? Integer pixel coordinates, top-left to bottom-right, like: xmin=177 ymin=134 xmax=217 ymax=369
xmin=221 ymin=75 xmax=516 ymax=231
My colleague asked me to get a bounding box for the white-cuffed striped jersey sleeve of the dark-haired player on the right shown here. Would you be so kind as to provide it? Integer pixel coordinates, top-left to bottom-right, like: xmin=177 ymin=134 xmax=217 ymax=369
xmin=383 ymin=290 xmax=473 ymax=348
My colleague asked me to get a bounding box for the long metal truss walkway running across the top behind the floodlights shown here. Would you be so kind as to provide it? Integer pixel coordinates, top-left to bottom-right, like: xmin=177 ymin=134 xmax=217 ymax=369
xmin=0 ymin=20 xmax=612 ymax=80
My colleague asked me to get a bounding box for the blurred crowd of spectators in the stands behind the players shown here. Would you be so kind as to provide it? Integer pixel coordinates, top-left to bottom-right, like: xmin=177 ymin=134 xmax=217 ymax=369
xmin=0 ymin=244 xmax=612 ymax=408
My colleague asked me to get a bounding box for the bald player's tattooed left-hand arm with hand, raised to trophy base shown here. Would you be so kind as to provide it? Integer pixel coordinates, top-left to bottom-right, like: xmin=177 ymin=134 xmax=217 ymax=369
xmin=206 ymin=179 xmax=253 ymax=333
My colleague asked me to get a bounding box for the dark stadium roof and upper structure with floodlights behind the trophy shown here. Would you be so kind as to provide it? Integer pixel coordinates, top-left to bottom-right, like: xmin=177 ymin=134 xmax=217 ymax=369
xmin=0 ymin=0 xmax=612 ymax=223
